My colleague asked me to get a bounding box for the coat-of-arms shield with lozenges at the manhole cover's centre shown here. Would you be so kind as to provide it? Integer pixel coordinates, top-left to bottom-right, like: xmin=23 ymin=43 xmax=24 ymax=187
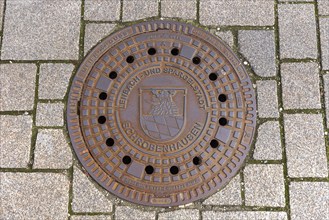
xmin=139 ymin=88 xmax=186 ymax=141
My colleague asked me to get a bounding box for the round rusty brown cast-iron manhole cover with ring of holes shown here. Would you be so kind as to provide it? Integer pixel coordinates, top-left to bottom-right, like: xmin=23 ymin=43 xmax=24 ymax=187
xmin=67 ymin=21 xmax=256 ymax=206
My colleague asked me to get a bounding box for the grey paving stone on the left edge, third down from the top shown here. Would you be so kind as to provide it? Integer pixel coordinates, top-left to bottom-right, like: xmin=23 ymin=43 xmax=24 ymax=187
xmin=0 ymin=115 xmax=32 ymax=168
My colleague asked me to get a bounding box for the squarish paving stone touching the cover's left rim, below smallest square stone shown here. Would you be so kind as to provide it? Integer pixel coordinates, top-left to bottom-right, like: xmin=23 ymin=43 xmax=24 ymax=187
xmin=33 ymin=129 xmax=72 ymax=169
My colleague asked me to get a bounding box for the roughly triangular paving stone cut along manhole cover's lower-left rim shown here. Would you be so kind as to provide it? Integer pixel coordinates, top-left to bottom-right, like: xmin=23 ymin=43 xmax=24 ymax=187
xmin=72 ymin=167 xmax=112 ymax=212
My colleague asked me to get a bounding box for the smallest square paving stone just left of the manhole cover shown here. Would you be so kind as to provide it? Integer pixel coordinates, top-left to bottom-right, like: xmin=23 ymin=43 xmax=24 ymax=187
xmin=36 ymin=103 xmax=64 ymax=127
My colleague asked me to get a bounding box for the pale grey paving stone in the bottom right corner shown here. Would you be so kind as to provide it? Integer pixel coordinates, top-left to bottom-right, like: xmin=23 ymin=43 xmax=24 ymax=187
xmin=289 ymin=182 xmax=329 ymax=219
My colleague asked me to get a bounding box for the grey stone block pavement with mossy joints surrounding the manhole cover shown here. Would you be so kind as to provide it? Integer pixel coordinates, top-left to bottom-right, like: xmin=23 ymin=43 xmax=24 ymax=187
xmin=0 ymin=0 xmax=329 ymax=220
